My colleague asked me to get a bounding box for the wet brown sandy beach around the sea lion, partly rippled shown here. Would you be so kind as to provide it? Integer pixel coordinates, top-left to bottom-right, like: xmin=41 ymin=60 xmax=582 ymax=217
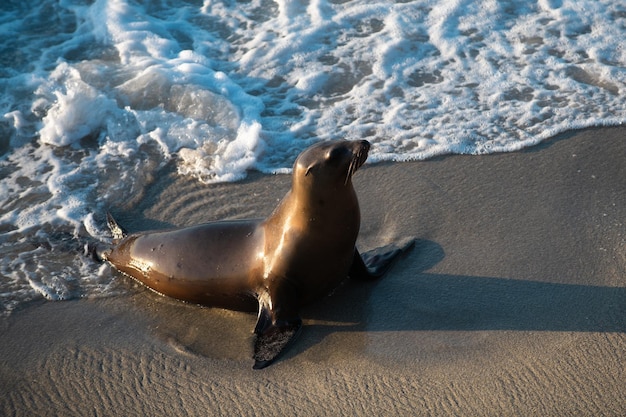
xmin=0 ymin=127 xmax=626 ymax=416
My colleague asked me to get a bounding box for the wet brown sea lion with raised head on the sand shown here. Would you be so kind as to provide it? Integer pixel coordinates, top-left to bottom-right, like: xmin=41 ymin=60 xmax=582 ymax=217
xmin=101 ymin=140 xmax=410 ymax=369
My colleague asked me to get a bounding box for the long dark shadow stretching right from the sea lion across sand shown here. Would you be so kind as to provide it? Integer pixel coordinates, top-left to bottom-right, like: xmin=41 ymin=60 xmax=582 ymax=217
xmin=285 ymin=240 xmax=626 ymax=357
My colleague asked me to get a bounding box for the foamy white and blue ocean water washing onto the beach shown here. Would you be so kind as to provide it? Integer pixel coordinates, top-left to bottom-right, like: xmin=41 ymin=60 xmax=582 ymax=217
xmin=0 ymin=0 xmax=626 ymax=314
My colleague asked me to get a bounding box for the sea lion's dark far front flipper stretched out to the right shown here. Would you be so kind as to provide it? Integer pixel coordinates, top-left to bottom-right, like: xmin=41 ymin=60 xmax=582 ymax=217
xmin=348 ymin=239 xmax=415 ymax=281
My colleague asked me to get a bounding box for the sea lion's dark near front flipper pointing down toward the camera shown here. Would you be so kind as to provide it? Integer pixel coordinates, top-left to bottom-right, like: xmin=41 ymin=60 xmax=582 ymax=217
xmin=253 ymin=290 xmax=302 ymax=369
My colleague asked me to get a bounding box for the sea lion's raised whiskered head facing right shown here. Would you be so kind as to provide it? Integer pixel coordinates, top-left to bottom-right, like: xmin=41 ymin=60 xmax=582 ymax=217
xmin=293 ymin=140 xmax=370 ymax=188
